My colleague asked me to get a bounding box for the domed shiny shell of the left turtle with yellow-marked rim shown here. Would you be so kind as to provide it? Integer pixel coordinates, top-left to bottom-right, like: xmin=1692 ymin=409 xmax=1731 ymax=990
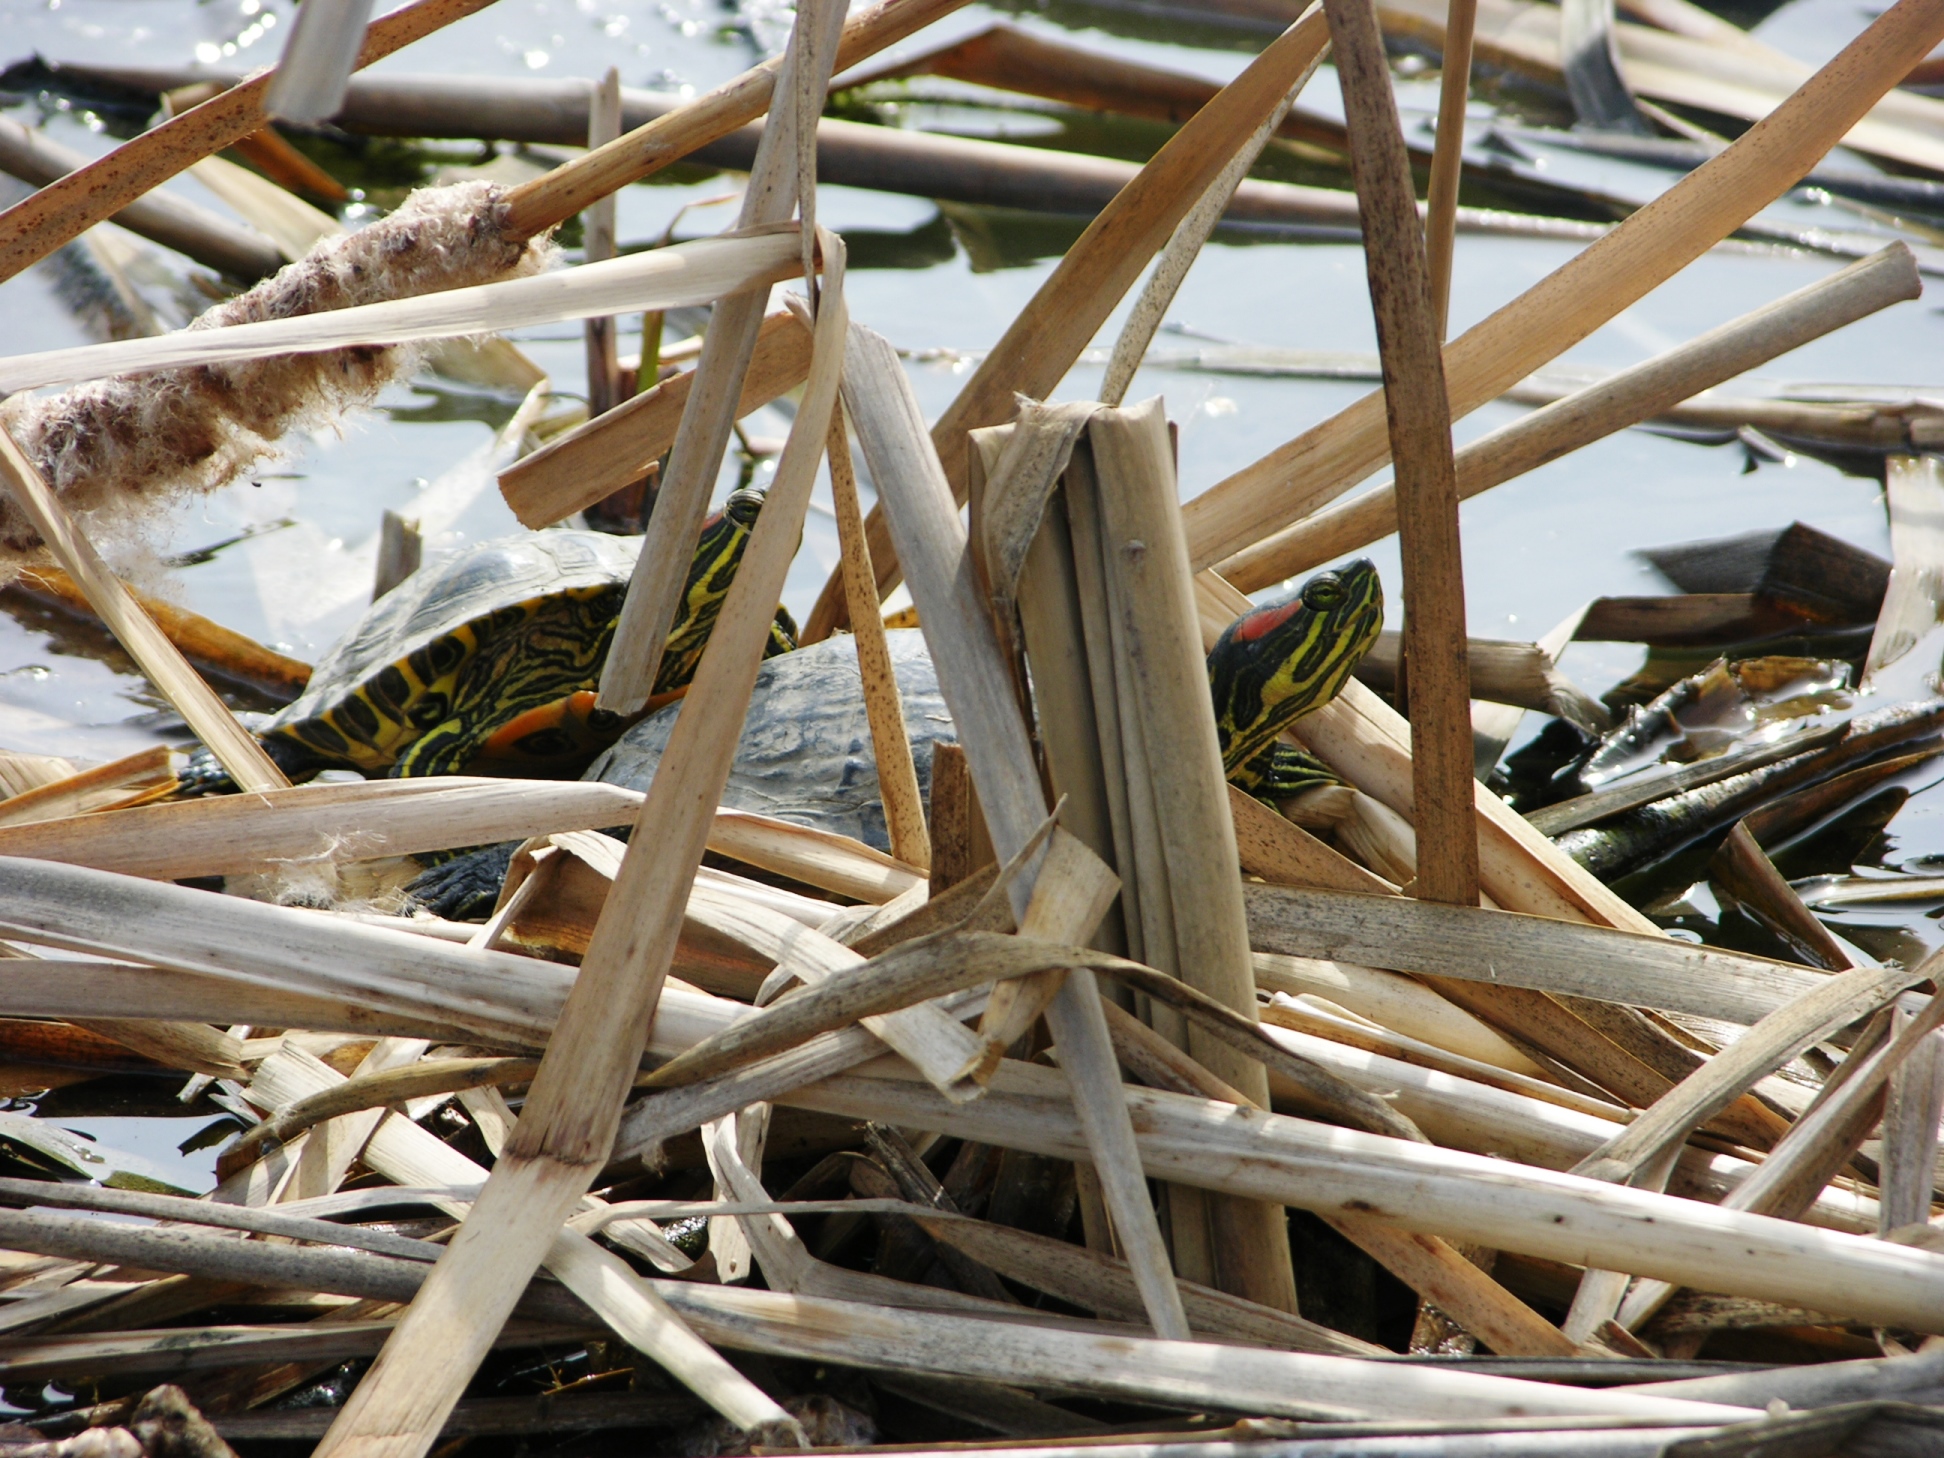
xmin=264 ymin=531 xmax=642 ymax=768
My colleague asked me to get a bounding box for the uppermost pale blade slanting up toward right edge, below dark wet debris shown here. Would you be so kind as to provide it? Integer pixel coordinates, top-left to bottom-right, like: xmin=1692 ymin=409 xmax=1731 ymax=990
xmin=1573 ymin=958 xmax=1936 ymax=1184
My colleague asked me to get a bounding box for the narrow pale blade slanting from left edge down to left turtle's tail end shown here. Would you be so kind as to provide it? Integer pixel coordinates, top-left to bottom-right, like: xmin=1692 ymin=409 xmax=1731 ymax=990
xmin=0 ymin=430 xmax=290 ymax=789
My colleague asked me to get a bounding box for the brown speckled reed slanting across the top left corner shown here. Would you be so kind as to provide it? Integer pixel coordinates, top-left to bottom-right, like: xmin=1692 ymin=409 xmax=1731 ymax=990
xmin=0 ymin=0 xmax=492 ymax=280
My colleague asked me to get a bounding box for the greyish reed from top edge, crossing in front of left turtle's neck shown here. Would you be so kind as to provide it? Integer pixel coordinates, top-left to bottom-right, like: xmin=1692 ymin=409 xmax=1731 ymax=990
xmin=597 ymin=4 xmax=844 ymax=715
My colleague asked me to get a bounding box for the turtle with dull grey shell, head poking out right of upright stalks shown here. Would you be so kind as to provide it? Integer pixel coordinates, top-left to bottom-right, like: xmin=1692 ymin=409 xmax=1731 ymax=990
xmin=410 ymin=558 xmax=1384 ymax=918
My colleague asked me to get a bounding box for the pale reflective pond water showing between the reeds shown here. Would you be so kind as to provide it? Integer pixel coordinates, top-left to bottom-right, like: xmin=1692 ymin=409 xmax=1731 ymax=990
xmin=0 ymin=0 xmax=1944 ymax=1174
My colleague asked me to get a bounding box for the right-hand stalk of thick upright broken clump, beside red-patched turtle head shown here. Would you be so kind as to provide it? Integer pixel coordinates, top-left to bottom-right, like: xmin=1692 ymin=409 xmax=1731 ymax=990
xmin=1087 ymin=399 xmax=1297 ymax=1312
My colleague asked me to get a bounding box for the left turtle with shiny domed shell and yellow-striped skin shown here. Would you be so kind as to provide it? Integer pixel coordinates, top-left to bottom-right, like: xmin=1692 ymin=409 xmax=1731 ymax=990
xmin=179 ymin=490 xmax=797 ymax=793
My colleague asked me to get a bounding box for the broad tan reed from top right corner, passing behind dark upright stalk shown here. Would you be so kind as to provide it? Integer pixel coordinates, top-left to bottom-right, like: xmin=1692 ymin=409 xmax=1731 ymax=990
xmin=1184 ymin=0 xmax=1944 ymax=587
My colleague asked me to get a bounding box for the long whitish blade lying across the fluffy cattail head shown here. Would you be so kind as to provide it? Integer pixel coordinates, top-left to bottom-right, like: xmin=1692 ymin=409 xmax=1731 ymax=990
xmin=0 ymin=227 xmax=797 ymax=391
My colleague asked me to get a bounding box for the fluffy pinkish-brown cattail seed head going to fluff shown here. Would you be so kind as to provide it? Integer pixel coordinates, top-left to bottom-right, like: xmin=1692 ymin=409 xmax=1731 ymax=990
xmin=0 ymin=183 xmax=552 ymax=579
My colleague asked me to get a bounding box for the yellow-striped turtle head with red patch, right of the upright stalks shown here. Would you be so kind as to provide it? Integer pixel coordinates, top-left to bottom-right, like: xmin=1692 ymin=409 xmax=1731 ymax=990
xmin=1209 ymin=558 xmax=1384 ymax=770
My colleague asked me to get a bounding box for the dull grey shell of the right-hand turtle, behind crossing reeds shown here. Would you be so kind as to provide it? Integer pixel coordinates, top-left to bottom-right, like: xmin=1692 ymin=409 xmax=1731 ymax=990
xmin=583 ymin=628 xmax=958 ymax=851
